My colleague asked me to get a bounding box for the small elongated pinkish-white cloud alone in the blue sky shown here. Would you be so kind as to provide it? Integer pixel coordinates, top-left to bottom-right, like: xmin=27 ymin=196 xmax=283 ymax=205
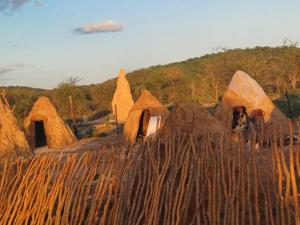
xmin=73 ymin=20 xmax=123 ymax=34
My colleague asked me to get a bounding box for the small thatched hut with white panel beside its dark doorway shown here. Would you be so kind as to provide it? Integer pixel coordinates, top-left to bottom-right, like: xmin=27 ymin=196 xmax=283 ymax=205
xmin=124 ymin=90 xmax=169 ymax=144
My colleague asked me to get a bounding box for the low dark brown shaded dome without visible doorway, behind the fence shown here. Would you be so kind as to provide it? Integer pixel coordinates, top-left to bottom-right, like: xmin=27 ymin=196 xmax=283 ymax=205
xmin=160 ymin=103 xmax=225 ymax=137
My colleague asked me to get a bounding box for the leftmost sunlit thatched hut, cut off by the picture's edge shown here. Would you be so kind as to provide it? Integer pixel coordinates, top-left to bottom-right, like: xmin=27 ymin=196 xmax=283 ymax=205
xmin=0 ymin=97 xmax=32 ymax=159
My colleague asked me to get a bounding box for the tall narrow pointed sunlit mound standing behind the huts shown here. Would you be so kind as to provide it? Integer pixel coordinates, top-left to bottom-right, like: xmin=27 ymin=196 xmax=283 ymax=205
xmin=111 ymin=69 xmax=134 ymax=123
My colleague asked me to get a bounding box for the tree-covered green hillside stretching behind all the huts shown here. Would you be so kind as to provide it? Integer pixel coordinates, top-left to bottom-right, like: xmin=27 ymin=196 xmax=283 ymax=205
xmin=1 ymin=45 xmax=300 ymax=124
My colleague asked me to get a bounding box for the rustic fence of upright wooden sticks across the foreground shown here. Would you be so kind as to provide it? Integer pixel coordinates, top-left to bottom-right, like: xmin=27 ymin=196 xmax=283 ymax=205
xmin=0 ymin=123 xmax=300 ymax=225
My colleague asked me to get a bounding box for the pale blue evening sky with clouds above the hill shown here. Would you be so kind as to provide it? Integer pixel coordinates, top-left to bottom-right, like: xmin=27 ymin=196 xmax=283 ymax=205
xmin=0 ymin=0 xmax=300 ymax=89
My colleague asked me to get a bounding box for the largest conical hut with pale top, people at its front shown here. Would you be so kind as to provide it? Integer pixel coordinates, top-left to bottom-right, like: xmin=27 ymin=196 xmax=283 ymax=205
xmin=215 ymin=71 xmax=288 ymax=133
